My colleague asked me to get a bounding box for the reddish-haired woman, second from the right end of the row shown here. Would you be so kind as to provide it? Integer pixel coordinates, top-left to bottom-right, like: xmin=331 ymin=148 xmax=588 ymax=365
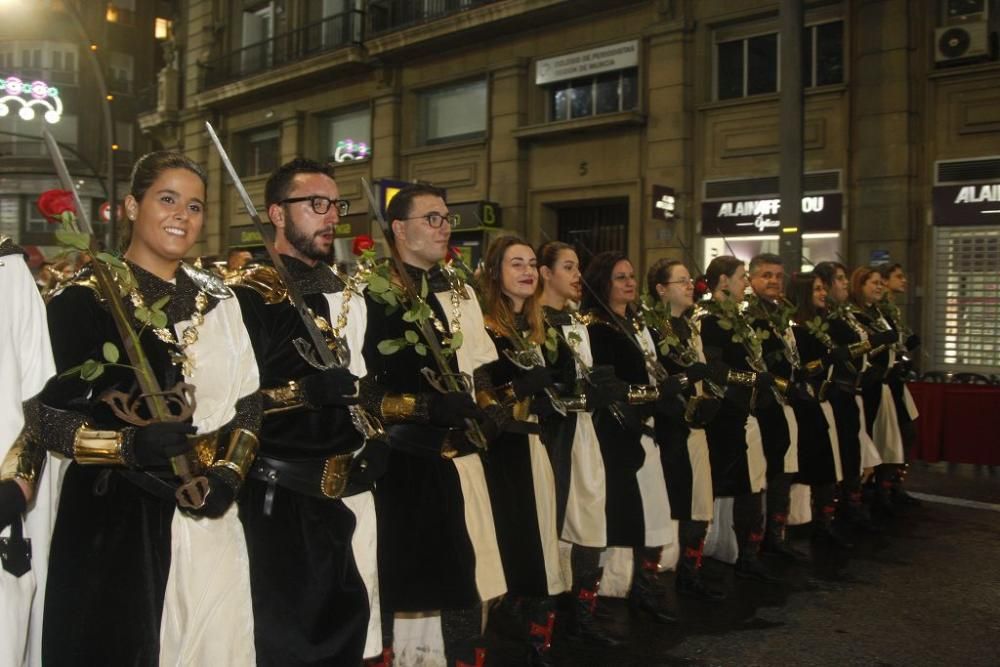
xmin=851 ymin=266 xmax=906 ymax=515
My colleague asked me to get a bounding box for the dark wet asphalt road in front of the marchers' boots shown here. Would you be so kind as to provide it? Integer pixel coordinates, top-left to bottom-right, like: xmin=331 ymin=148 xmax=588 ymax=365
xmin=491 ymin=466 xmax=1000 ymax=667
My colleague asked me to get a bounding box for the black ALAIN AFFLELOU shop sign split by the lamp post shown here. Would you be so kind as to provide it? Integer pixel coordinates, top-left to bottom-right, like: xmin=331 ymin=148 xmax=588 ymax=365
xmin=701 ymin=192 xmax=843 ymax=236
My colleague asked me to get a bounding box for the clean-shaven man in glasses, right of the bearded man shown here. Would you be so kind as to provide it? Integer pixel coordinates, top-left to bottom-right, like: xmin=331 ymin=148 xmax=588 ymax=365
xmin=361 ymin=184 xmax=507 ymax=665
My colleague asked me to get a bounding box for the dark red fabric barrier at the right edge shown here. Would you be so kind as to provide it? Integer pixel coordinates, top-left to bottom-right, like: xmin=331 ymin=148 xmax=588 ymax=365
xmin=908 ymin=382 xmax=1000 ymax=466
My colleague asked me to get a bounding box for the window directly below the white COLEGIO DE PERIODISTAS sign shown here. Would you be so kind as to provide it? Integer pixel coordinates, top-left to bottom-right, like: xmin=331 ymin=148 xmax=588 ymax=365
xmin=549 ymin=67 xmax=639 ymax=120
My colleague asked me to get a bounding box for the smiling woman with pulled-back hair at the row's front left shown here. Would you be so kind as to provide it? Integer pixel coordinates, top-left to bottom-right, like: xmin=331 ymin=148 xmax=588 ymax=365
xmin=32 ymin=151 xmax=260 ymax=667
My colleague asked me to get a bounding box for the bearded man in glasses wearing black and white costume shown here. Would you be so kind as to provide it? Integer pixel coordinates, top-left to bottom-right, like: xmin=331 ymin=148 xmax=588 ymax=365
xmin=234 ymin=158 xmax=384 ymax=666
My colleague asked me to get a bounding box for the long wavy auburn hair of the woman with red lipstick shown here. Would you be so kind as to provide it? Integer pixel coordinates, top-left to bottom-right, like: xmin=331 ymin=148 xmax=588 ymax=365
xmin=479 ymin=236 xmax=545 ymax=344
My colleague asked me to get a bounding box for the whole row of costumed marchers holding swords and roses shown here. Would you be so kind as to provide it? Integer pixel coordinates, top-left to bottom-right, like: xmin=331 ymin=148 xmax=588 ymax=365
xmin=0 ymin=152 xmax=917 ymax=667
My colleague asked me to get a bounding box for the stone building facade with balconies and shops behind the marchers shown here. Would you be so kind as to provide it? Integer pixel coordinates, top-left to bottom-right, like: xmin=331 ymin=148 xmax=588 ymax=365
xmin=139 ymin=0 xmax=1000 ymax=371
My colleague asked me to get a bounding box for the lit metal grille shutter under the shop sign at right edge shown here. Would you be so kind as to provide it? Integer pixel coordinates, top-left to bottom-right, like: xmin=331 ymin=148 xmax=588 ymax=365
xmin=933 ymin=227 xmax=1000 ymax=372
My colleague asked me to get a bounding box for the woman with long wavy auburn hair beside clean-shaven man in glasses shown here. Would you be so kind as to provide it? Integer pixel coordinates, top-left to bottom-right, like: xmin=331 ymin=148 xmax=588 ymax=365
xmin=477 ymin=236 xmax=567 ymax=665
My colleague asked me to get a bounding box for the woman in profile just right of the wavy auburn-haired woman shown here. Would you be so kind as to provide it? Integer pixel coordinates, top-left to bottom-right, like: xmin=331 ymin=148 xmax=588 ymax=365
xmin=538 ymin=241 xmax=626 ymax=646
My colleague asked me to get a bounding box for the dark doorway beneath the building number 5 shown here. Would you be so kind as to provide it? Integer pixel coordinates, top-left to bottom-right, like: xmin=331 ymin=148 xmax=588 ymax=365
xmin=556 ymin=199 xmax=628 ymax=267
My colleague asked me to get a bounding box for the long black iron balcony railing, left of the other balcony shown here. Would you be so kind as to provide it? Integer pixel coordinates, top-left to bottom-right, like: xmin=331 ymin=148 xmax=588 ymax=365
xmin=205 ymin=9 xmax=364 ymax=88
